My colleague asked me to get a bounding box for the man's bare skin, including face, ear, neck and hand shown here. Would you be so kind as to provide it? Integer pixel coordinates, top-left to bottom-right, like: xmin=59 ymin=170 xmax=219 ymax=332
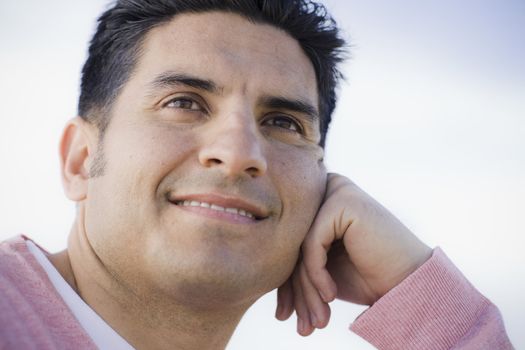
xmin=50 ymin=12 xmax=431 ymax=349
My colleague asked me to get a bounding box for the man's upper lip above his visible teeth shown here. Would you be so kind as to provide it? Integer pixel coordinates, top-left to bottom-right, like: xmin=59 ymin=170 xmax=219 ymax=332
xmin=168 ymin=193 xmax=269 ymax=219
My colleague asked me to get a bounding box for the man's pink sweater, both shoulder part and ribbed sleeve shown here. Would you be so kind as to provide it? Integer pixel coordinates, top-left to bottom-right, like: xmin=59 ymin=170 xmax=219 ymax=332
xmin=0 ymin=236 xmax=513 ymax=350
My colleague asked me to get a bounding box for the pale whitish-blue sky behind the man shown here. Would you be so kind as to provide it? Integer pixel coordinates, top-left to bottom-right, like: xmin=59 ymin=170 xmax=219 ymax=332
xmin=0 ymin=0 xmax=525 ymax=349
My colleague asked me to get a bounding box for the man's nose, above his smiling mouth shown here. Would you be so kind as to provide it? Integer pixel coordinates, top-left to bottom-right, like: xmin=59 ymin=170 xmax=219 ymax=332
xmin=199 ymin=116 xmax=268 ymax=177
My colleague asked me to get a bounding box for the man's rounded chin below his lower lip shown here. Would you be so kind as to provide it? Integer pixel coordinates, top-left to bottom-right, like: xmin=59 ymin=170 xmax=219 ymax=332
xmin=141 ymin=226 xmax=299 ymax=309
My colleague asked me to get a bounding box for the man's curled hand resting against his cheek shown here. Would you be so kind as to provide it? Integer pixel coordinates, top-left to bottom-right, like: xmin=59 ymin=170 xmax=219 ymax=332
xmin=276 ymin=174 xmax=432 ymax=336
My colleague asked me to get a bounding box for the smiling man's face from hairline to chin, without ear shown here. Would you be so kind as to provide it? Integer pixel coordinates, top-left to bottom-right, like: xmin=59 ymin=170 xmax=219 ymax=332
xmin=82 ymin=12 xmax=326 ymax=303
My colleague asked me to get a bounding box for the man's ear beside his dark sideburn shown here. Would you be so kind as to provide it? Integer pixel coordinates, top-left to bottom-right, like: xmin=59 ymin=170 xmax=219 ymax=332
xmin=59 ymin=117 xmax=98 ymax=202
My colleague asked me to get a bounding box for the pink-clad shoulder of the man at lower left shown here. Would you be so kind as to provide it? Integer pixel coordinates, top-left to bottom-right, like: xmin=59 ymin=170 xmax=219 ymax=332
xmin=0 ymin=236 xmax=93 ymax=349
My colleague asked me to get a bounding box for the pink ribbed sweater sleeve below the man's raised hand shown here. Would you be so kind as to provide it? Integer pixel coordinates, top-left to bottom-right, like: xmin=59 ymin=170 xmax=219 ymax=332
xmin=350 ymin=248 xmax=513 ymax=350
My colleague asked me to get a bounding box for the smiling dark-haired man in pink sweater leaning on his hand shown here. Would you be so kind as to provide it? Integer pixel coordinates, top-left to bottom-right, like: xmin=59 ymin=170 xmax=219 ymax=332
xmin=0 ymin=0 xmax=512 ymax=349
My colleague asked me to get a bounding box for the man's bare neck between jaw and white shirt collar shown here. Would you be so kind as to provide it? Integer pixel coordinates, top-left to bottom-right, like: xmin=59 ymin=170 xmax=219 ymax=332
xmin=50 ymin=219 xmax=253 ymax=349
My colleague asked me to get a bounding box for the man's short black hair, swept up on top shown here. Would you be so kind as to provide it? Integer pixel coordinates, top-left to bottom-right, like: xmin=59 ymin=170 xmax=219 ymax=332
xmin=78 ymin=0 xmax=346 ymax=147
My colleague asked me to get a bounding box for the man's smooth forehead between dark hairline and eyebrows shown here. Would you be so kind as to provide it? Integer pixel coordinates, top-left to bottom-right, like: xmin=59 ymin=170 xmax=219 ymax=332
xmin=134 ymin=12 xmax=317 ymax=106
